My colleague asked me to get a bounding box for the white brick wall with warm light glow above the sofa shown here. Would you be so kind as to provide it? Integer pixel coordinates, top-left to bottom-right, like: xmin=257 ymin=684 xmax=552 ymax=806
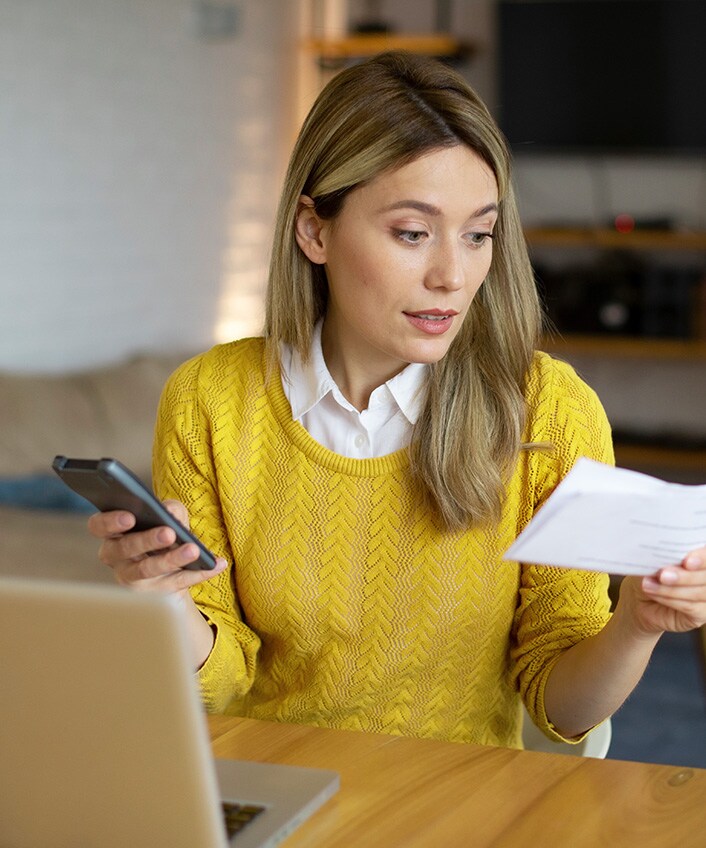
xmin=0 ymin=0 xmax=293 ymax=371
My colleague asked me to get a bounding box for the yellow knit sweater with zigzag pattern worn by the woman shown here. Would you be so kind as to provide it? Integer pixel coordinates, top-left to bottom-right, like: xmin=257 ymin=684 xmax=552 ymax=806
xmin=154 ymin=339 xmax=612 ymax=746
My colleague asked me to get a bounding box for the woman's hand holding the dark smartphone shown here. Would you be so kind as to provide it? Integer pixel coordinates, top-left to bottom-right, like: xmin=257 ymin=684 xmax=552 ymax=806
xmin=88 ymin=501 xmax=227 ymax=600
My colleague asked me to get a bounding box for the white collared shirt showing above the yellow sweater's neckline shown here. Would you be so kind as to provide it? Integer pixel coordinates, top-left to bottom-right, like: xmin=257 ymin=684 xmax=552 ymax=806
xmin=280 ymin=321 xmax=428 ymax=459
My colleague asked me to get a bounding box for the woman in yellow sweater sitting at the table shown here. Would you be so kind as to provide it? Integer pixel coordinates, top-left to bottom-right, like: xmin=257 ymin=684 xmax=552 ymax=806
xmin=90 ymin=54 xmax=706 ymax=746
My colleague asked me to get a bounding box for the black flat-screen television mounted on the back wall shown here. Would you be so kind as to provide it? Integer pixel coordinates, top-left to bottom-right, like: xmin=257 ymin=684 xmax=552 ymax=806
xmin=497 ymin=0 xmax=706 ymax=155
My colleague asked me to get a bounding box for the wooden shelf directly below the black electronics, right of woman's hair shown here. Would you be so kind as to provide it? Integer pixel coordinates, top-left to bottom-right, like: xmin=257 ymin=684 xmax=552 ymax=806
xmin=542 ymin=334 xmax=706 ymax=361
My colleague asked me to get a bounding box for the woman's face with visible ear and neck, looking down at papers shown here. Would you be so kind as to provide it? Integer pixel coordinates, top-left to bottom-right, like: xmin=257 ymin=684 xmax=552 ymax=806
xmin=297 ymin=145 xmax=498 ymax=400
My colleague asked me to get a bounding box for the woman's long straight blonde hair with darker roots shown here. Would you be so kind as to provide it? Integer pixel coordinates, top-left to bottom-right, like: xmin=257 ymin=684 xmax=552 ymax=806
xmin=265 ymin=53 xmax=542 ymax=529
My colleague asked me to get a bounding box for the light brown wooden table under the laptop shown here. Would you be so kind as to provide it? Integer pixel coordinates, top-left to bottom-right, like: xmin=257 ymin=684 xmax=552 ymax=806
xmin=209 ymin=716 xmax=706 ymax=848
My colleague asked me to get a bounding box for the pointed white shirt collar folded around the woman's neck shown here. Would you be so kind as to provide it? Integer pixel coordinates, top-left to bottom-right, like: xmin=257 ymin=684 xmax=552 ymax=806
xmin=281 ymin=321 xmax=428 ymax=424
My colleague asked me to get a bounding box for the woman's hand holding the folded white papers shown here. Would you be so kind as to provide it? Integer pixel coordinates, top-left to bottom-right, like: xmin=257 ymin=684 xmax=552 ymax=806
xmin=619 ymin=546 xmax=706 ymax=634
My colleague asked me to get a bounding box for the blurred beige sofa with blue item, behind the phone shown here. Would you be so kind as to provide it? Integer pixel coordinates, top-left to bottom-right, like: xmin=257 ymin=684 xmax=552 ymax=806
xmin=0 ymin=353 xmax=188 ymax=582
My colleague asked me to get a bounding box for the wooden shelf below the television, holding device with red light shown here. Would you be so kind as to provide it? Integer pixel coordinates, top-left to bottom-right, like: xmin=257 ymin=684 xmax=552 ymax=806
xmin=525 ymin=227 xmax=706 ymax=250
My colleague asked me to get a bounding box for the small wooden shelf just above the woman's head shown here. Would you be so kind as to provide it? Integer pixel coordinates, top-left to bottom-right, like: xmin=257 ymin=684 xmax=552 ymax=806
xmin=303 ymin=33 xmax=469 ymax=62
